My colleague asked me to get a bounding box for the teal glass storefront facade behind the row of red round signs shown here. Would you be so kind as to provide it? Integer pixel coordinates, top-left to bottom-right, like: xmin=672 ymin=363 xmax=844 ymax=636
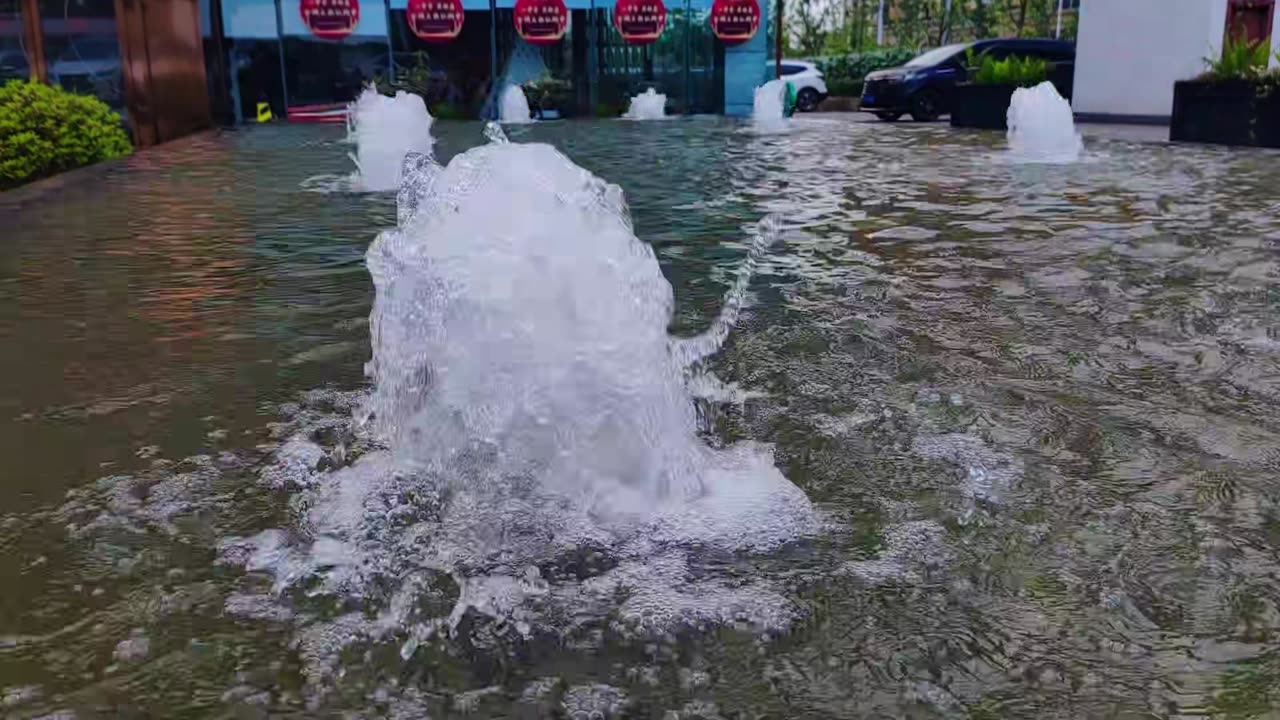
xmin=201 ymin=0 xmax=772 ymax=122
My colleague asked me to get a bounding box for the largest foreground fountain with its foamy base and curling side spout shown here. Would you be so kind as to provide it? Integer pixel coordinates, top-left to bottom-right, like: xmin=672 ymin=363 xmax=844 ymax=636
xmin=224 ymin=123 xmax=819 ymax=691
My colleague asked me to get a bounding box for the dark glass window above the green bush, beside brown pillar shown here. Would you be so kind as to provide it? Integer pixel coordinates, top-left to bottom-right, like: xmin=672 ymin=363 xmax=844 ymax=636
xmin=40 ymin=0 xmax=124 ymax=109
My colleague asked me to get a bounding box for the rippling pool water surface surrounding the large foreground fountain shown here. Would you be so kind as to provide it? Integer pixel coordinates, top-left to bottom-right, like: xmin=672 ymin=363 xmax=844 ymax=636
xmin=0 ymin=118 xmax=1280 ymax=717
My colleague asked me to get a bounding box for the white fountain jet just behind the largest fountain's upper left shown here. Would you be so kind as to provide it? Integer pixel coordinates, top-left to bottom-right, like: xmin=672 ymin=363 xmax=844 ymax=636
xmin=347 ymin=86 xmax=435 ymax=192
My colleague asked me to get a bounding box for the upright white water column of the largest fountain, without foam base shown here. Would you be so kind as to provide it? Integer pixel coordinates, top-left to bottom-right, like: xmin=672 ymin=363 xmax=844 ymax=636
xmin=369 ymin=122 xmax=785 ymax=518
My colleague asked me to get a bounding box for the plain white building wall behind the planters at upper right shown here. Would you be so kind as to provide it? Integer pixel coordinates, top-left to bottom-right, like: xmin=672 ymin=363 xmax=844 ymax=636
xmin=1071 ymin=0 xmax=1280 ymax=117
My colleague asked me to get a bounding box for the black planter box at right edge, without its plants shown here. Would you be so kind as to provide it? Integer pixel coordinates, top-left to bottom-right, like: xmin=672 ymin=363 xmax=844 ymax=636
xmin=1169 ymin=79 xmax=1280 ymax=147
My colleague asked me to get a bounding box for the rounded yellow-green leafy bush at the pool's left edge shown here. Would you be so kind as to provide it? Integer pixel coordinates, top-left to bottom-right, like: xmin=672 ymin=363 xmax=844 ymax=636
xmin=0 ymin=79 xmax=132 ymax=187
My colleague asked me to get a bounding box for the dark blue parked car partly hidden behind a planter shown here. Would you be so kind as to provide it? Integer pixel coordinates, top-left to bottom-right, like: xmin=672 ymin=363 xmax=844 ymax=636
xmin=861 ymin=38 xmax=1075 ymax=122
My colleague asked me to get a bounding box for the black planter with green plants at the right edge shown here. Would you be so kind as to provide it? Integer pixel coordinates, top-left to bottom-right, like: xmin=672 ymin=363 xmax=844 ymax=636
xmin=1169 ymin=41 xmax=1280 ymax=147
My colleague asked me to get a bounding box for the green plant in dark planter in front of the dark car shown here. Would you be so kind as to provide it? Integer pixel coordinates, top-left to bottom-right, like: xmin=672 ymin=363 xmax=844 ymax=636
xmin=951 ymin=51 xmax=1048 ymax=129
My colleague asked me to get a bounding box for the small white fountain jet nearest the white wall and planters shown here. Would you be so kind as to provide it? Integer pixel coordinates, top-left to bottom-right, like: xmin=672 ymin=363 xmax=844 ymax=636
xmin=1009 ymin=81 xmax=1084 ymax=163
